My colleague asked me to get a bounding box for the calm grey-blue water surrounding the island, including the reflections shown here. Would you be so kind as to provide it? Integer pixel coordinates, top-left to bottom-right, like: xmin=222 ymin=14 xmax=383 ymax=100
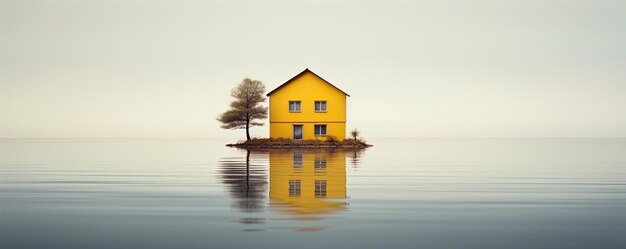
xmin=0 ymin=139 xmax=626 ymax=249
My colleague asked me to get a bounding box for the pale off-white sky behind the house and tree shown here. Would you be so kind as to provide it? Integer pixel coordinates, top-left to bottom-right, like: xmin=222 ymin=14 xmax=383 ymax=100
xmin=0 ymin=0 xmax=626 ymax=138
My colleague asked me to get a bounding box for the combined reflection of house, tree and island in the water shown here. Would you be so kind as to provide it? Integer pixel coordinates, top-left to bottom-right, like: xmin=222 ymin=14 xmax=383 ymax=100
xmin=218 ymin=149 xmax=360 ymax=231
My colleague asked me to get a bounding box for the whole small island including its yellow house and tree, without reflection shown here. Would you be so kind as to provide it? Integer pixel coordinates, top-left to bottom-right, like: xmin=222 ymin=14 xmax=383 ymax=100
xmin=217 ymin=68 xmax=372 ymax=149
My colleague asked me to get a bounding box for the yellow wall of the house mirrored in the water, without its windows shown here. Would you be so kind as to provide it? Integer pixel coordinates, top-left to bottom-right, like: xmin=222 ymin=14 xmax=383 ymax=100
xmin=269 ymin=150 xmax=346 ymax=214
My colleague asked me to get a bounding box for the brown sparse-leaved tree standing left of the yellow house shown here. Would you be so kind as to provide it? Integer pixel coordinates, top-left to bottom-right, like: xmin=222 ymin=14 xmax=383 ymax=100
xmin=217 ymin=78 xmax=267 ymax=140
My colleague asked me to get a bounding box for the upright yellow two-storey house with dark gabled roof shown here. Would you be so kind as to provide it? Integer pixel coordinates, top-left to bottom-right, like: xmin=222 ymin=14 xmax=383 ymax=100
xmin=267 ymin=68 xmax=350 ymax=139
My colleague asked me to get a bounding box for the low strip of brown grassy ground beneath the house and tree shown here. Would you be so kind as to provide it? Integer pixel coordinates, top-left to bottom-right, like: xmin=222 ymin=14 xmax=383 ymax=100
xmin=226 ymin=137 xmax=372 ymax=148
